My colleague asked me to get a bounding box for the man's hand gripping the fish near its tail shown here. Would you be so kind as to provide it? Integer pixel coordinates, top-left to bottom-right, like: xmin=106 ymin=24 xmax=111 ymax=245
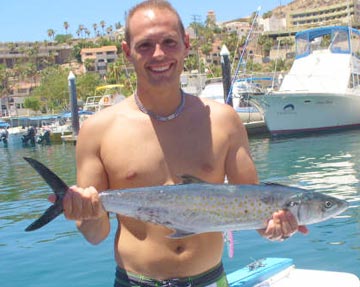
xmin=48 ymin=186 xmax=106 ymax=220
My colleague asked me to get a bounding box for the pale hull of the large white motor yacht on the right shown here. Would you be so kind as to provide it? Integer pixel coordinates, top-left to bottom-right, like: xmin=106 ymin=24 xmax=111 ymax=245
xmin=261 ymin=92 xmax=360 ymax=135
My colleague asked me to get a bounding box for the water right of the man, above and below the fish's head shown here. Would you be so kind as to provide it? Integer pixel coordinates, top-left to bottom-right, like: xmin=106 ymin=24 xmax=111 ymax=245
xmin=245 ymin=130 xmax=360 ymax=276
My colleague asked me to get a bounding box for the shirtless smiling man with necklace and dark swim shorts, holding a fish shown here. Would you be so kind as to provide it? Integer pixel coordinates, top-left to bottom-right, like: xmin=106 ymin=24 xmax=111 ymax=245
xmin=64 ymin=0 xmax=306 ymax=286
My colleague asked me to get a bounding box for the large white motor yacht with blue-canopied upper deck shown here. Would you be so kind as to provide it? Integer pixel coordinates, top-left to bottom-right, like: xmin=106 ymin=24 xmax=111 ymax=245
xmin=252 ymin=26 xmax=360 ymax=135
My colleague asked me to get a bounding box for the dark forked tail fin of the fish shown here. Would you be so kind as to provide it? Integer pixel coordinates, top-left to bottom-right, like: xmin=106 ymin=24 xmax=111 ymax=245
xmin=24 ymin=157 xmax=69 ymax=231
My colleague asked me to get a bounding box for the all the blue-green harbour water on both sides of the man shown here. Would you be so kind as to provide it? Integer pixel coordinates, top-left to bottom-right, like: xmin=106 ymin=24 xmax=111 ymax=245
xmin=0 ymin=130 xmax=360 ymax=287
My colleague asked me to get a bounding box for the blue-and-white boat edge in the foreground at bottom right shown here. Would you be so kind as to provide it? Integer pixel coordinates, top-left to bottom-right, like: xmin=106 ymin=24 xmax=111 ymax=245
xmin=227 ymin=258 xmax=360 ymax=287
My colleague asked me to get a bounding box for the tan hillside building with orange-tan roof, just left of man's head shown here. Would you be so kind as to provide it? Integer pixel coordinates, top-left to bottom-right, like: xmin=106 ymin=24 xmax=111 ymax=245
xmin=80 ymin=46 xmax=117 ymax=76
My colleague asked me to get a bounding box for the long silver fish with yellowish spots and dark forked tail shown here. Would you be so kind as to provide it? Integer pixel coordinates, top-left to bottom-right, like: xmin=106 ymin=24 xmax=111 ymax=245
xmin=25 ymin=158 xmax=348 ymax=238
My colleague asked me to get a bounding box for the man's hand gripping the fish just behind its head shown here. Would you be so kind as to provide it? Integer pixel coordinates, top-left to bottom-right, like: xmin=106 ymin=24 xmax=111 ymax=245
xmin=258 ymin=210 xmax=309 ymax=241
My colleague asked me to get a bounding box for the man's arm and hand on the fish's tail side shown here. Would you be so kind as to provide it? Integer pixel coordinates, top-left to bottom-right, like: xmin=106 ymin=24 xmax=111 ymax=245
xmin=64 ymin=119 xmax=110 ymax=244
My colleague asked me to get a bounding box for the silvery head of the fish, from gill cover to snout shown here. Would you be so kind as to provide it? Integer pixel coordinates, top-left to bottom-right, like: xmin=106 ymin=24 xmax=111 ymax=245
xmin=285 ymin=191 xmax=349 ymax=225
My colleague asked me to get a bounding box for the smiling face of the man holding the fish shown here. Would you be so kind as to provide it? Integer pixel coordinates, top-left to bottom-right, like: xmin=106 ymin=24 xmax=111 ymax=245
xmin=123 ymin=9 xmax=189 ymax=86
